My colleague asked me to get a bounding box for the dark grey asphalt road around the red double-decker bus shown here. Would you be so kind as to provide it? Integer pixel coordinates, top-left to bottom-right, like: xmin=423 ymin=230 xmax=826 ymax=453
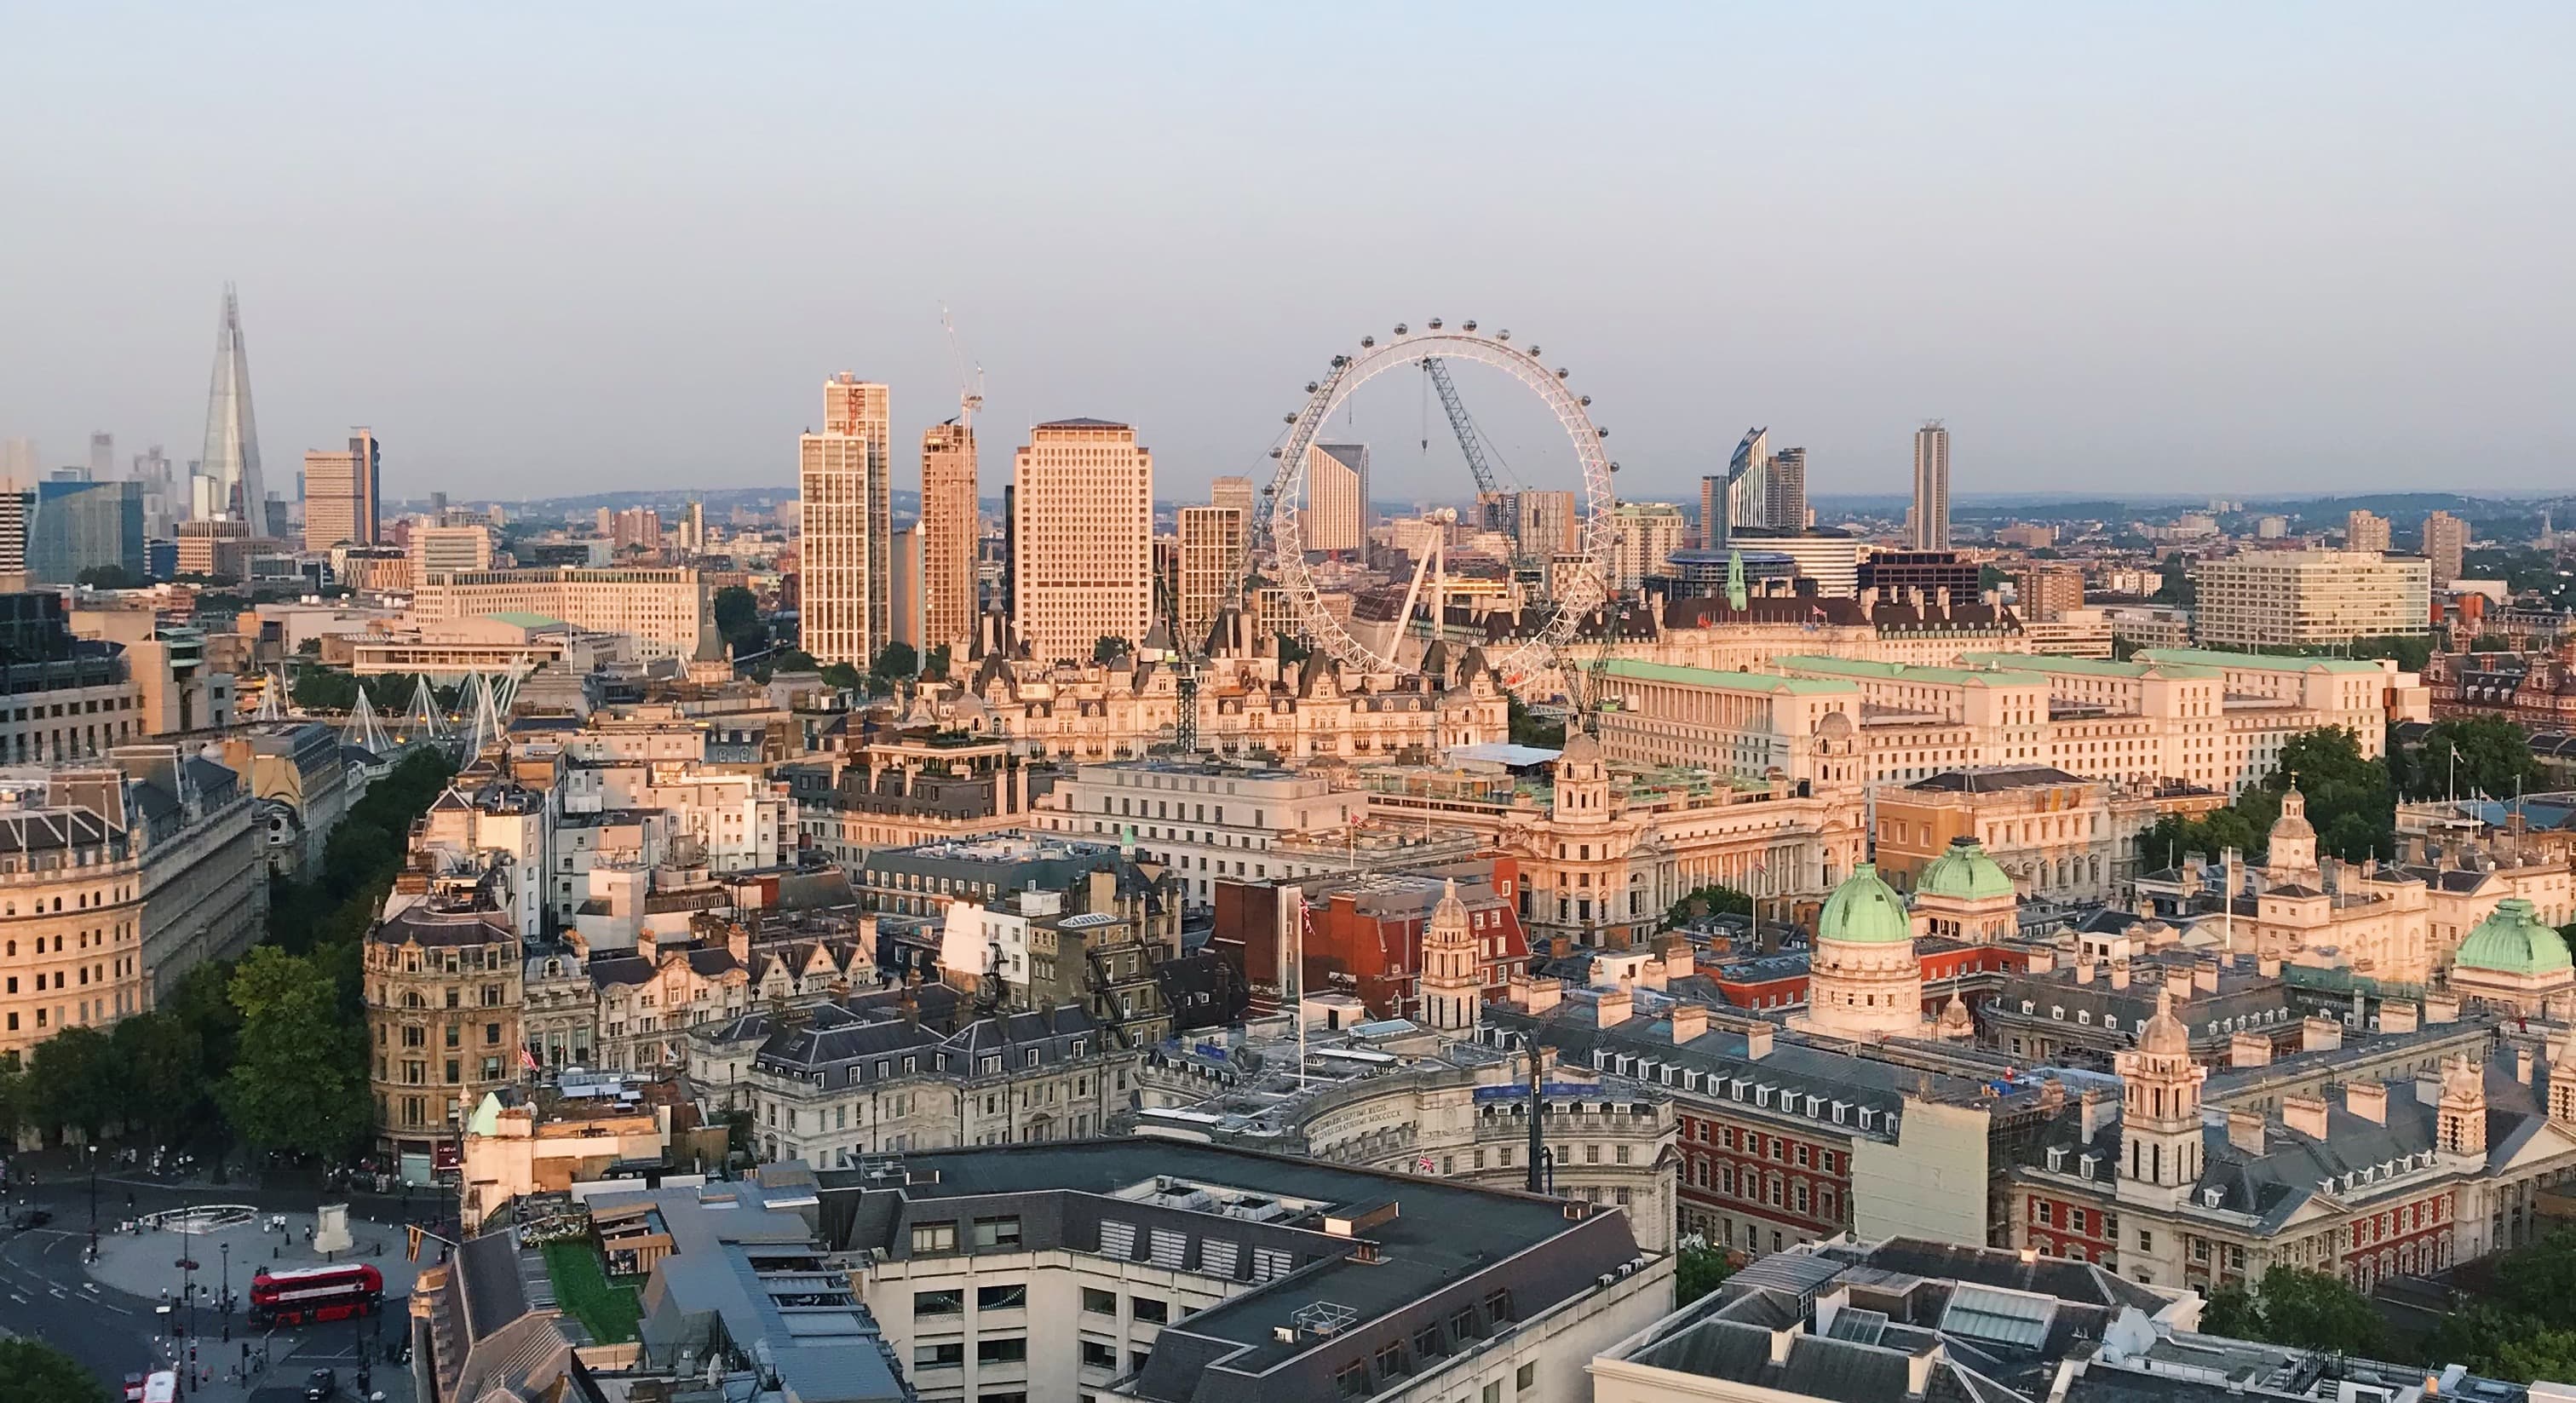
xmin=0 ymin=1158 xmax=453 ymax=1403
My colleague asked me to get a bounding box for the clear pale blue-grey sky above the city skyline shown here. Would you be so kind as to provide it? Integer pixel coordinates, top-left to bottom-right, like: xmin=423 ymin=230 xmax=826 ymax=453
xmin=0 ymin=0 xmax=2576 ymax=499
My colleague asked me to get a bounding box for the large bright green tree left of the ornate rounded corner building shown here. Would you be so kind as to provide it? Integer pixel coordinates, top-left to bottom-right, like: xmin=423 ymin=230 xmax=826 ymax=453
xmin=224 ymin=945 xmax=368 ymax=1159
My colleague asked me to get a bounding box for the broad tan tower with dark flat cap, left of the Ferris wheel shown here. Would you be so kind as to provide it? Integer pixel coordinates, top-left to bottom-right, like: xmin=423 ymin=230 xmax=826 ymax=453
xmin=1009 ymin=420 xmax=1154 ymax=662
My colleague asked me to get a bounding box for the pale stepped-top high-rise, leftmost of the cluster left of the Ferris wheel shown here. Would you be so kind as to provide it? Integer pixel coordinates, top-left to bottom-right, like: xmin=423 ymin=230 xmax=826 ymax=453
xmin=796 ymin=371 xmax=894 ymax=672
